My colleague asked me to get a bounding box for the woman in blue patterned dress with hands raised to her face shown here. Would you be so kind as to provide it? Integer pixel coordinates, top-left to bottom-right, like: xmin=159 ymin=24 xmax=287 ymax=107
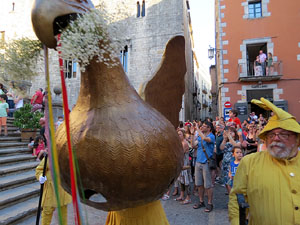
xmin=220 ymin=127 xmax=241 ymax=194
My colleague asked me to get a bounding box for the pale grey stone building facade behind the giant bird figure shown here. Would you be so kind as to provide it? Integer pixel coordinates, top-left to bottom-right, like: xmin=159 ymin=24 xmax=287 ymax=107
xmin=0 ymin=0 xmax=194 ymax=120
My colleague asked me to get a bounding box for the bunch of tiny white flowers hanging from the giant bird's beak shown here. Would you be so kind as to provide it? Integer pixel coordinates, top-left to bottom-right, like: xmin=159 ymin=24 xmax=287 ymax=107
xmin=58 ymin=8 xmax=126 ymax=71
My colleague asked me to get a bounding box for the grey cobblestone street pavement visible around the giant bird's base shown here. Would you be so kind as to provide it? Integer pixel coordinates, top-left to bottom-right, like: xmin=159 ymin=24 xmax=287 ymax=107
xmin=47 ymin=184 xmax=229 ymax=225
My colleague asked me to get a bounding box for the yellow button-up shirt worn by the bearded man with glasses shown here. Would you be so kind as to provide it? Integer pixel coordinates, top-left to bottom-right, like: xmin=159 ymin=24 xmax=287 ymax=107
xmin=228 ymin=151 xmax=300 ymax=225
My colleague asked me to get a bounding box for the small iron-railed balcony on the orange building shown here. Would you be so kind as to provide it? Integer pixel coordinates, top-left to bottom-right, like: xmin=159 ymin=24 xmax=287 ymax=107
xmin=238 ymin=61 xmax=283 ymax=82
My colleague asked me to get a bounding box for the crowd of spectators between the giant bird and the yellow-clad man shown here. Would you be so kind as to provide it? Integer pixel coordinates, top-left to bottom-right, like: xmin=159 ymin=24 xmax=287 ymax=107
xmin=162 ymin=109 xmax=267 ymax=212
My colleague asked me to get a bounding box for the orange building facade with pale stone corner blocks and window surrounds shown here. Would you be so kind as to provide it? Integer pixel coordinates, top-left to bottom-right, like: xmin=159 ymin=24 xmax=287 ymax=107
xmin=215 ymin=0 xmax=300 ymax=121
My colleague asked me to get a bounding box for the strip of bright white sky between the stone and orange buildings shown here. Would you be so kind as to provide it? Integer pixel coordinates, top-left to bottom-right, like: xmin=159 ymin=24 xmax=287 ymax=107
xmin=189 ymin=0 xmax=215 ymax=81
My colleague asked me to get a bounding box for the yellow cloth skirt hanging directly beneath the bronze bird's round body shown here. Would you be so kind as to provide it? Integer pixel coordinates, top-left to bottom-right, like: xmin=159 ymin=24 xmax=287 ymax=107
xmin=105 ymin=201 xmax=169 ymax=225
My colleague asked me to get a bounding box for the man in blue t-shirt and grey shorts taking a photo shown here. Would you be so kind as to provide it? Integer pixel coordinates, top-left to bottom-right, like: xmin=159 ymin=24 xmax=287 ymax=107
xmin=192 ymin=121 xmax=215 ymax=212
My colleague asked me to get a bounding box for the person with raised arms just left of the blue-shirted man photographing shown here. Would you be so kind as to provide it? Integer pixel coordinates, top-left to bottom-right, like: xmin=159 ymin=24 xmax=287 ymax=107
xmin=176 ymin=130 xmax=193 ymax=205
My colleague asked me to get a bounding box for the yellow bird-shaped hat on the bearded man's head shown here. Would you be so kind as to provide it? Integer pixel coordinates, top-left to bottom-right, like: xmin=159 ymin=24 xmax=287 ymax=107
xmin=251 ymin=98 xmax=300 ymax=140
